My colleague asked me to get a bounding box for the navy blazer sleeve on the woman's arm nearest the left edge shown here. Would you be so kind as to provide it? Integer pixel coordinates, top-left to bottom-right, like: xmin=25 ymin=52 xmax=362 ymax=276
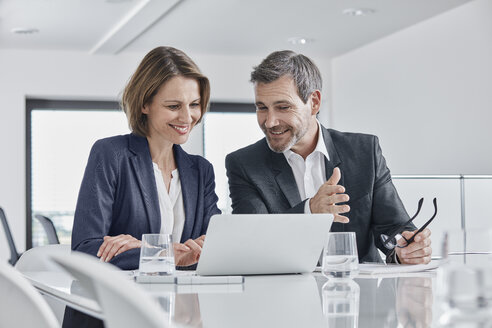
xmin=72 ymin=141 xmax=140 ymax=270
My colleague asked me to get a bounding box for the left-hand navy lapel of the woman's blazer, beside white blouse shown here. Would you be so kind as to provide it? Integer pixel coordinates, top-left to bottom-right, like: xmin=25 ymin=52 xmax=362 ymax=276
xmin=129 ymin=134 xmax=161 ymax=233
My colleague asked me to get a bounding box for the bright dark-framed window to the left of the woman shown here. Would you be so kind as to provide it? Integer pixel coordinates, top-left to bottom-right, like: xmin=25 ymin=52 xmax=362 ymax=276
xmin=26 ymin=100 xmax=129 ymax=248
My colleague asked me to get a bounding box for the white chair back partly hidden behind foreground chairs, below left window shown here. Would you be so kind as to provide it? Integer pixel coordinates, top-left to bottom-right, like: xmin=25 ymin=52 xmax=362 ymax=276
xmin=15 ymin=244 xmax=72 ymax=272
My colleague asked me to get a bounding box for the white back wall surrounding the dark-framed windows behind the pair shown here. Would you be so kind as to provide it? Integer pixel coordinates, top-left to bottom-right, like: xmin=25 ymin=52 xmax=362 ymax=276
xmin=0 ymin=50 xmax=330 ymax=259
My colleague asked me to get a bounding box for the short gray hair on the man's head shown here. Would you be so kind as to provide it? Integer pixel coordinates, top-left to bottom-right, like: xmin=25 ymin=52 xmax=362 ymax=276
xmin=251 ymin=50 xmax=323 ymax=103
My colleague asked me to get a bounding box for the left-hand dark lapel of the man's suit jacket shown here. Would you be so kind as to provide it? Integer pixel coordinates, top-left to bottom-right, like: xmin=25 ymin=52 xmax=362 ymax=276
xmin=270 ymin=151 xmax=302 ymax=207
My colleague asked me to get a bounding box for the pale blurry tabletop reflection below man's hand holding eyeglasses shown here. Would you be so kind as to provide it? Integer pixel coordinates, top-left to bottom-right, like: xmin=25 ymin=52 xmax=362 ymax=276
xmin=396 ymin=277 xmax=433 ymax=327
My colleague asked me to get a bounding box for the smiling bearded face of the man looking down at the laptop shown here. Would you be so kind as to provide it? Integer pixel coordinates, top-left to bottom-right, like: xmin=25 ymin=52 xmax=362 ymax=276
xmin=255 ymin=76 xmax=319 ymax=153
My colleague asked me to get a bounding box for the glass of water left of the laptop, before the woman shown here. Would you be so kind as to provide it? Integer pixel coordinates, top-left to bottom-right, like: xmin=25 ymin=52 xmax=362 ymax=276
xmin=138 ymin=234 xmax=176 ymax=276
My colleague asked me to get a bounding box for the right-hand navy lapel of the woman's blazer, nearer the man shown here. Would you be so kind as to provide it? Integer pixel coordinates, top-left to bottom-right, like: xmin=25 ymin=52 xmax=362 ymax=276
xmin=173 ymin=145 xmax=199 ymax=242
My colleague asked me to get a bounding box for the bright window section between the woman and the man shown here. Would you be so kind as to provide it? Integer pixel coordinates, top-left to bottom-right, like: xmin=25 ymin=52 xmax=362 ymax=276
xmin=203 ymin=103 xmax=264 ymax=213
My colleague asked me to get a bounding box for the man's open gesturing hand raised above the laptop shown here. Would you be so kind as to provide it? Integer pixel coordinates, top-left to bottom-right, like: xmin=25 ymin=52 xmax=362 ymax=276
xmin=309 ymin=167 xmax=350 ymax=223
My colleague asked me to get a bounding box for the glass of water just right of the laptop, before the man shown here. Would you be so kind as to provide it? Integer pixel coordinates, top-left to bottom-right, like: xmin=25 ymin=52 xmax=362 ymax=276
xmin=322 ymin=232 xmax=359 ymax=278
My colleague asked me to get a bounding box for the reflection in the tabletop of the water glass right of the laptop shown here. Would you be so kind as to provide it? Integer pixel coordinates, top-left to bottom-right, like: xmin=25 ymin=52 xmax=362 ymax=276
xmin=321 ymin=279 xmax=360 ymax=328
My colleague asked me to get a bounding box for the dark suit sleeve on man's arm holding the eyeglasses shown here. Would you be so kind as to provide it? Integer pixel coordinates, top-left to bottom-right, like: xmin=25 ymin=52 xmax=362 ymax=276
xmin=372 ymin=137 xmax=415 ymax=256
